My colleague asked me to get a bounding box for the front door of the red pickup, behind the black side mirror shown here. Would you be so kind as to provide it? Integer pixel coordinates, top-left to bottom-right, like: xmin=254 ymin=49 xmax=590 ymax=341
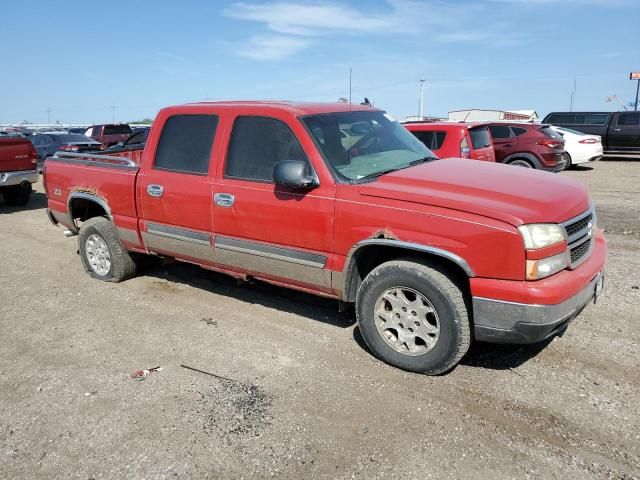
xmin=213 ymin=115 xmax=335 ymax=292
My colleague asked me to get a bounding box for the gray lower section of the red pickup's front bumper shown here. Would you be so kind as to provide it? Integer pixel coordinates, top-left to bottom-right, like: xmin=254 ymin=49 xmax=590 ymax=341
xmin=473 ymin=273 xmax=604 ymax=343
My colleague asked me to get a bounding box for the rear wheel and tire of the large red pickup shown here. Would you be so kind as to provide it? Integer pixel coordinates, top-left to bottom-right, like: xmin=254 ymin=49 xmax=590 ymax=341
xmin=78 ymin=217 xmax=137 ymax=283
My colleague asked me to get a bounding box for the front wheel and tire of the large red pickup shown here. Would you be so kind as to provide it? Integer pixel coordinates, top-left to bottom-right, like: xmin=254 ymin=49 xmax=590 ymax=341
xmin=356 ymin=260 xmax=471 ymax=375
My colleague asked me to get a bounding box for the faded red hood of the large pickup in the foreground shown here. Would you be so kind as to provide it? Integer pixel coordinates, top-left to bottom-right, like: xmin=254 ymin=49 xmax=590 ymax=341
xmin=359 ymin=159 xmax=590 ymax=226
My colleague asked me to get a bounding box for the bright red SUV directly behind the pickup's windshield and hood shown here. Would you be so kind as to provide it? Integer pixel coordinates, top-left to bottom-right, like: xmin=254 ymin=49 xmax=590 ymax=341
xmin=404 ymin=122 xmax=496 ymax=162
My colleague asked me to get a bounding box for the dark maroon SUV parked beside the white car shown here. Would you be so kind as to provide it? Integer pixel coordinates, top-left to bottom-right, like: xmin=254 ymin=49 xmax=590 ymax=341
xmin=489 ymin=122 xmax=565 ymax=172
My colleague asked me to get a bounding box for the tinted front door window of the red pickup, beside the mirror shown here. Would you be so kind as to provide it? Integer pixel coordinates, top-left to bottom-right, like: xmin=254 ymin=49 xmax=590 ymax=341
xmin=224 ymin=117 xmax=308 ymax=182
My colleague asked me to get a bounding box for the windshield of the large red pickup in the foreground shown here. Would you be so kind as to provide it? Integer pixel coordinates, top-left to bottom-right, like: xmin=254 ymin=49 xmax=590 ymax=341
xmin=302 ymin=111 xmax=435 ymax=181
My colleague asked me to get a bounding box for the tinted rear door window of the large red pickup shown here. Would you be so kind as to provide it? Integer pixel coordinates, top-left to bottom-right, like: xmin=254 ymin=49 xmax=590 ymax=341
xmin=153 ymin=115 xmax=218 ymax=175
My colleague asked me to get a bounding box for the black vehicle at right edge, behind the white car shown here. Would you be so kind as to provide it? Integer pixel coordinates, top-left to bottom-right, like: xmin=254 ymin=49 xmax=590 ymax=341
xmin=542 ymin=112 xmax=640 ymax=154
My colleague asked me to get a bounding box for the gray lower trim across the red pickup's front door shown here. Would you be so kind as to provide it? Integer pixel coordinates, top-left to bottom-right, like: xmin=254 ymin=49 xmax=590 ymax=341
xmin=214 ymin=236 xmax=331 ymax=288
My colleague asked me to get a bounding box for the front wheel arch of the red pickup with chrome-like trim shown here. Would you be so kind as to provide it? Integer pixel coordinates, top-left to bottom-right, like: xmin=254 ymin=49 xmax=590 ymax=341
xmin=338 ymin=238 xmax=475 ymax=302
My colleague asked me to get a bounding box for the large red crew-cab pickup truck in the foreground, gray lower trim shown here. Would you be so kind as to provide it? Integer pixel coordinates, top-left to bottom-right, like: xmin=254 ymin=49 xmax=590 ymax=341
xmin=44 ymin=102 xmax=606 ymax=374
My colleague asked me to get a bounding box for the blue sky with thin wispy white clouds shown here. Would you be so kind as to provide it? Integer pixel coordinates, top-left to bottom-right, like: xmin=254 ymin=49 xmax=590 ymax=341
xmin=0 ymin=0 xmax=640 ymax=123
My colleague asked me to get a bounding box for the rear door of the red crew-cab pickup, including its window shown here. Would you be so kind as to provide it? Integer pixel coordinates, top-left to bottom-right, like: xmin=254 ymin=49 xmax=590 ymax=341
xmin=138 ymin=113 xmax=218 ymax=263
